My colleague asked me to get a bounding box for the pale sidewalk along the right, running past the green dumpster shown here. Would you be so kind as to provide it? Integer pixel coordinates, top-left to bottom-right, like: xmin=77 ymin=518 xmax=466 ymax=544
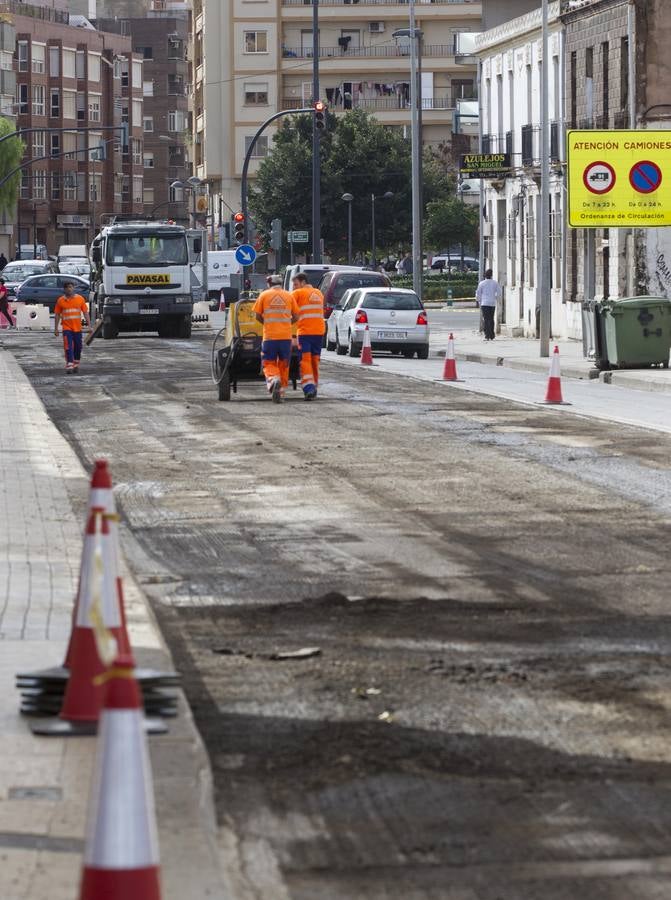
xmin=431 ymin=310 xmax=671 ymax=392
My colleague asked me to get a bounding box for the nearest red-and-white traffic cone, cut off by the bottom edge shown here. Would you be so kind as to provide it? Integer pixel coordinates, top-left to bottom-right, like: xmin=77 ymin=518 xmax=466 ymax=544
xmin=79 ymin=657 xmax=161 ymax=900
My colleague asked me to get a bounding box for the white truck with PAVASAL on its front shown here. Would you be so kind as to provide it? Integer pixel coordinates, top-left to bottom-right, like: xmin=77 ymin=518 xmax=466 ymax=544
xmin=91 ymin=221 xmax=193 ymax=340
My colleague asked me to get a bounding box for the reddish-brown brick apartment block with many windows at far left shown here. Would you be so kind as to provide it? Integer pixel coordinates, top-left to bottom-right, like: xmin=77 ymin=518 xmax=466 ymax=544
xmin=9 ymin=0 xmax=143 ymax=252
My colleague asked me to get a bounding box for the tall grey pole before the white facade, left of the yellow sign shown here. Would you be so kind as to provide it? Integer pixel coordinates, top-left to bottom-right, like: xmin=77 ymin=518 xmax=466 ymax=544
xmin=536 ymin=0 xmax=552 ymax=356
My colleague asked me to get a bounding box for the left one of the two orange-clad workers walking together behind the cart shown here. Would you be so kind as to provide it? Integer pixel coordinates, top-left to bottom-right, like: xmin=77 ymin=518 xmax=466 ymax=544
xmin=254 ymin=275 xmax=298 ymax=403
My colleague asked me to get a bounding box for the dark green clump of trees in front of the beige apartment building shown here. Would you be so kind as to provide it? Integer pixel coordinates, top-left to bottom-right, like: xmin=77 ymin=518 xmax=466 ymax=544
xmin=249 ymin=110 xmax=454 ymax=259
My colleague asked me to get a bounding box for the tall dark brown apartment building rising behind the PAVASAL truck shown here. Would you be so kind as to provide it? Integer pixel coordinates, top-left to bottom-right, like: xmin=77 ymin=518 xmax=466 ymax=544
xmin=96 ymin=11 xmax=191 ymax=222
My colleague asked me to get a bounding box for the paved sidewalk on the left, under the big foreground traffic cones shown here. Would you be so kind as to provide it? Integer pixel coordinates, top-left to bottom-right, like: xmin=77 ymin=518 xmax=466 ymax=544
xmin=0 ymin=350 xmax=228 ymax=900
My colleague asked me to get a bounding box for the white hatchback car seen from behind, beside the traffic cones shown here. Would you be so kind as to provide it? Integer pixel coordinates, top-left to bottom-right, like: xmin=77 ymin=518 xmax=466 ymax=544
xmin=327 ymin=287 xmax=429 ymax=359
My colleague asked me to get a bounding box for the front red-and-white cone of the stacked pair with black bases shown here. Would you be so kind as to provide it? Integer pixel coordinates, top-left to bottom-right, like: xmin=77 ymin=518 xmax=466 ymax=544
xmin=60 ymin=507 xmax=121 ymax=723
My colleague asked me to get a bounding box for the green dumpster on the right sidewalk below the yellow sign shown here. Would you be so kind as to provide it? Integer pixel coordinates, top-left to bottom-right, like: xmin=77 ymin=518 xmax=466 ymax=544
xmin=599 ymin=297 xmax=671 ymax=369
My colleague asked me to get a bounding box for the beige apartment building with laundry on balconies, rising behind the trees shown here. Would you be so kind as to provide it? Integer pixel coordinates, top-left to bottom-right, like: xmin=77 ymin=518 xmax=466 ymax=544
xmin=193 ymin=0 xmax=481 ymax=223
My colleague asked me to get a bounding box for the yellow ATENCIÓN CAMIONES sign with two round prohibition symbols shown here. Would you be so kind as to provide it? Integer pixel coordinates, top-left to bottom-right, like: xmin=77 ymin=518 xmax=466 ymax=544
xmin=567 ymin=131 xmax=671 ymax=228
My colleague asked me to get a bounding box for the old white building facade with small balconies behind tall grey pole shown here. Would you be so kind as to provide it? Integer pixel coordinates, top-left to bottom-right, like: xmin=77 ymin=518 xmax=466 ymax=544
xmin=476 ymin=2 xmax=581 ymax=337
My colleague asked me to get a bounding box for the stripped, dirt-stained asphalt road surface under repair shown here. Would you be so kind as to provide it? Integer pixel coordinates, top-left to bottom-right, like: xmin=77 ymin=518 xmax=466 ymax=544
xmin=6 ymin=335 xmax=671 ymax=900
